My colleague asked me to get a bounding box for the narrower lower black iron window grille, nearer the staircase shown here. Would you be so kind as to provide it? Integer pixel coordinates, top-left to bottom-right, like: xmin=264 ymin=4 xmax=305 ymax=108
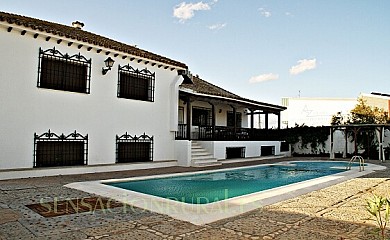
xmin=116 ymin=132 xmax=153 ymax=163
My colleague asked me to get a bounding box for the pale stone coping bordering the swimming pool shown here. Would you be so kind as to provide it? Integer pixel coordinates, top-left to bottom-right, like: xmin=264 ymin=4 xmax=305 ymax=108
xmin=65 ymin=161 xmax=386 ymax=225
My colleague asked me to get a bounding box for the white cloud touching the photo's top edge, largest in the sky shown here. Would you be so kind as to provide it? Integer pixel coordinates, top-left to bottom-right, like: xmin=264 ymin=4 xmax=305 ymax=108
xmin=173 ymin=1 xmax=212 ymax=23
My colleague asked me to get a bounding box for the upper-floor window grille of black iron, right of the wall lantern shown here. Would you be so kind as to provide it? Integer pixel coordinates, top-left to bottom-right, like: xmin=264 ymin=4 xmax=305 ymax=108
xmin=117 ymin=64 xmax=155 ymax=102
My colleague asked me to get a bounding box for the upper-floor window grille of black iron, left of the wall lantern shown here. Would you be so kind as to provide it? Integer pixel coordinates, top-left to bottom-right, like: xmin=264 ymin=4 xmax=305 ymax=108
xmin=37 ymin=48 xmax=91 ymax=93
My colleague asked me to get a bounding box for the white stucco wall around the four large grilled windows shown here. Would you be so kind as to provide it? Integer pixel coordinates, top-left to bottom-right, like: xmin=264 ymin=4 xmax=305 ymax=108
xmin=0 ymin=25 xmax=182 ymax=169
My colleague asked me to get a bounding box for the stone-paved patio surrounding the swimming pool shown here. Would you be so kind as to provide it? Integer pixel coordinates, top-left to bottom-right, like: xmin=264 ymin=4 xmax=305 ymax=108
xmin=0 ymin=158 xmax=390 ymax=240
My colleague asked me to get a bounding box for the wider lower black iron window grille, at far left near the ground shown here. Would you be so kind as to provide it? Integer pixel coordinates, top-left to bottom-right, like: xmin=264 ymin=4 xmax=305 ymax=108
xmin=34 ymin=129 xmax=88 ymax=167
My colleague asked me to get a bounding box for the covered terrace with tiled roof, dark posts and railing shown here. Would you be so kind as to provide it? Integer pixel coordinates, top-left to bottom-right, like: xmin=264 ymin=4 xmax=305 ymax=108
xmin=176 ymin=77 xmax=286 ymax=141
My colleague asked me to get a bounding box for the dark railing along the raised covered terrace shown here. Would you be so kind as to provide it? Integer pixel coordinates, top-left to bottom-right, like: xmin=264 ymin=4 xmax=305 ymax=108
xmin=176 ymin=124 xmax=284 ymax=141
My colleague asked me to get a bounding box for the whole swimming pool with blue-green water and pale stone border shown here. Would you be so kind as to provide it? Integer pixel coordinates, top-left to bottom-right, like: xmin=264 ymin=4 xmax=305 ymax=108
xmin=65 ymin=161 xmax=385 ymax=225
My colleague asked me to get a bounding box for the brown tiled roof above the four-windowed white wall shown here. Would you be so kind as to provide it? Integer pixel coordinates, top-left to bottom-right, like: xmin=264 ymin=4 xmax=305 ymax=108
xmin=0 ymin=11 xmax=187 ymax=68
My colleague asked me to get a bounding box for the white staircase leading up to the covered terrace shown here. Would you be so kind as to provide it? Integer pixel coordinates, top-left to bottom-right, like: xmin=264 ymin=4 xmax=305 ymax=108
xmin=191 ymin=141 xmax=222 ymax=167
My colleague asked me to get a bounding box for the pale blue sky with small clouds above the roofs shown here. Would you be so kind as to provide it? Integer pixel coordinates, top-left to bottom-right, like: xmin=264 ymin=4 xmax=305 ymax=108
xmin=0 ymin=0 xmax=390 ymax=105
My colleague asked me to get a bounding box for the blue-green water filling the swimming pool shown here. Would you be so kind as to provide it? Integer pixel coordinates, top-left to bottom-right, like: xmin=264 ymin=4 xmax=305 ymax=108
xmin=106 ymin=161 xmax=360 ymax=204
